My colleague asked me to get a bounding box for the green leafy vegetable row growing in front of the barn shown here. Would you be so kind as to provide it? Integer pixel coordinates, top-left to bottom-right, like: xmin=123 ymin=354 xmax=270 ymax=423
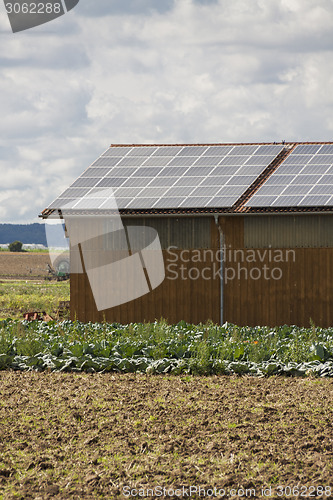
xmin=0 ymin=319 xmax=333 ymax=376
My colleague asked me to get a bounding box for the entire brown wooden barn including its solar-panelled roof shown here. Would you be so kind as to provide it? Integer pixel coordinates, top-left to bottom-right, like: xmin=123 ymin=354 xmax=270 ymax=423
xmin=41 ymin=142 xmax=333 ymax=327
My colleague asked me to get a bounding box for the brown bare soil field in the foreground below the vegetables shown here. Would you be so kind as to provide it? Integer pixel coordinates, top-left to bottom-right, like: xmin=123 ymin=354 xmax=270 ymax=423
xmin=0 ymin=372 xmax=333 ymax=500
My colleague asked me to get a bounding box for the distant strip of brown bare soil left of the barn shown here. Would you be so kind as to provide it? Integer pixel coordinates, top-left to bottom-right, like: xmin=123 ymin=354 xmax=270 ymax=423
xmin=0 ymin=252 xmax=51 ymax=279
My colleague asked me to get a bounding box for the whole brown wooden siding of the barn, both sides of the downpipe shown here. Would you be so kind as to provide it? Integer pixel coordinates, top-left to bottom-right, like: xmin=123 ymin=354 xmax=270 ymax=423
xmin=71 ymin=215 xmax=333 ymax=327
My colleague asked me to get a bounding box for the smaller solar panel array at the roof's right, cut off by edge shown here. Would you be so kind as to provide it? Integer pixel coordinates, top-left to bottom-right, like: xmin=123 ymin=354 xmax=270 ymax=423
xmin=245 ymin=144 xmax=333 ymax=207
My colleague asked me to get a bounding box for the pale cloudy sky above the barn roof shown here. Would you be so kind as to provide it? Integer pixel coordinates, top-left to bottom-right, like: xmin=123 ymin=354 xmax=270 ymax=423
xmin=0 ymin=0 xmax=333 ymax=223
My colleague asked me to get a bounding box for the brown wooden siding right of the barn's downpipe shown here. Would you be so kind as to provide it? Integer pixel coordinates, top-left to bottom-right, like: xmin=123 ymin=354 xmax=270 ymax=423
xmin=221 ymin=215 xmax=333 ymax=327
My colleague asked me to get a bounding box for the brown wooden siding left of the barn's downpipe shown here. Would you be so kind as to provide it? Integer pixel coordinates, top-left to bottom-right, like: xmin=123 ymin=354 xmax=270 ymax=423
xmin=70 ymin=217 xmax=220 ymax=324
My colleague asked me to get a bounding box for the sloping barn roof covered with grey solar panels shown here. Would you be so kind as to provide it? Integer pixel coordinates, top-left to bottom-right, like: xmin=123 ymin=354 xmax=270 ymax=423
xmin=41 ymin=142 xmax=333 ymax=218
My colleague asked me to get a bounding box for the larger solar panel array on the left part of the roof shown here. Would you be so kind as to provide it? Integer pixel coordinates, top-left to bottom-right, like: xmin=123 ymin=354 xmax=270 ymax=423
xmin=49 ymin=145 xmax=283 ymax=210
